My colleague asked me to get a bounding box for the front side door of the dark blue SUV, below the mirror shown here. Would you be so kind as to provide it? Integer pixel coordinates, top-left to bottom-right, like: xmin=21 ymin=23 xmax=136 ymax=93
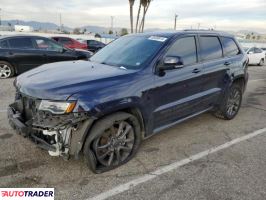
xmin=152 ymin=35 xmax=204 ymax=132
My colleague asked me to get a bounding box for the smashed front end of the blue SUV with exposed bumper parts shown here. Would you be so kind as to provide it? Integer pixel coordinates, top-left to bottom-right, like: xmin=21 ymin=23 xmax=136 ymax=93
xmin=8 ymin=94 xmax=94 ymax=159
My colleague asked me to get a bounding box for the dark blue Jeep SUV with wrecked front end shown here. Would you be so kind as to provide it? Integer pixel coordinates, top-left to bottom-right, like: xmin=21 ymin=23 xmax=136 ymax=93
xmin=8 ymin=31 xmax=248 ymax=173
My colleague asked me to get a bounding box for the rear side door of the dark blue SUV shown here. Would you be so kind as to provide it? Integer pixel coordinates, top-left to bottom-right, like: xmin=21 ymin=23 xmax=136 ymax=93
xmin=199 ymin=35 xmax=234 ymax=106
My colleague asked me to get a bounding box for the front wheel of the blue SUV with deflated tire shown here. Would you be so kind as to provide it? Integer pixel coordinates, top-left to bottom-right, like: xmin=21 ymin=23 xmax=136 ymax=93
xmin=83 ymin=112 xmax=141 ymax=173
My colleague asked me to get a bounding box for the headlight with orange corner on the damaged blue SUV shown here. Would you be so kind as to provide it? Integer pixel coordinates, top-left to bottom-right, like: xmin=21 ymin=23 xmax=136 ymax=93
xmin=39 ymin=100 xmax=76 ymax=114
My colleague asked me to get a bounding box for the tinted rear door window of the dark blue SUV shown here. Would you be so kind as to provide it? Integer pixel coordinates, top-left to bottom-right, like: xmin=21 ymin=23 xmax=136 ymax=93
xmin=200 ymin=36 xmax=223 ymax=60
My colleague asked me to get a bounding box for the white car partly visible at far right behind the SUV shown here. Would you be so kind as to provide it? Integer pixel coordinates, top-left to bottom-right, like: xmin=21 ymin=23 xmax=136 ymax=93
xmin=245 ymin=47 xmax=265 ymax=66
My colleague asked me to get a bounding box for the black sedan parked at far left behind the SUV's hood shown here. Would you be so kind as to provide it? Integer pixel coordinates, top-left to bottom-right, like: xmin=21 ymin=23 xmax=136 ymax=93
xmin=0 ymin=36 xmax=92 ymax=78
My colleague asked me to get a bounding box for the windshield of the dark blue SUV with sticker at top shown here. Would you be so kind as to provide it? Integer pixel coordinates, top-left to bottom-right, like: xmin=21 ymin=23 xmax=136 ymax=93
xmin=90 ymin=36 xmax=167 ymax=69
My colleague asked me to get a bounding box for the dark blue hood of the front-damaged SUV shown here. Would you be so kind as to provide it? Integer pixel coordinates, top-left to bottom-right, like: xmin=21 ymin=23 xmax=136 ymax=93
xmin=15 ymin=61 xmax=135 ymax=100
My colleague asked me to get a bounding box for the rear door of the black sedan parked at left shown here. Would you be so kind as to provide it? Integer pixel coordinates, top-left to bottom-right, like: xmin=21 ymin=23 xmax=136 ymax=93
xmin=8 ymin=37 xmax=45 ymax=73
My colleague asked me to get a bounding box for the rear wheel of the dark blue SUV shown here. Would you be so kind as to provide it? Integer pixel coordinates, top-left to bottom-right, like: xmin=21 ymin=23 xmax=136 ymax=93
xmin=214 ymin=84 xmax=242 ymax=120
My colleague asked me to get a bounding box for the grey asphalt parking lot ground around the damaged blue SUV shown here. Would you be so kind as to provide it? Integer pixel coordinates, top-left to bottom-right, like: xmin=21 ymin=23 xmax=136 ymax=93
xmin=0 ymin=66 xmax=266 ymax=200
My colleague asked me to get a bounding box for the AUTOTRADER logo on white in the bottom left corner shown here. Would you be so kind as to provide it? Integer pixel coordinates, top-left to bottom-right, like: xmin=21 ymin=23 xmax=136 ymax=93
xmin=0 ymin=188 xmax=54 ymax=200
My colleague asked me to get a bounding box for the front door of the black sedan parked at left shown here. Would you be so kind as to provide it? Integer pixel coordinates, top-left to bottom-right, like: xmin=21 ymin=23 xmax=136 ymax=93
xmin=35 ymin=38 xmax=77 ymax=63
